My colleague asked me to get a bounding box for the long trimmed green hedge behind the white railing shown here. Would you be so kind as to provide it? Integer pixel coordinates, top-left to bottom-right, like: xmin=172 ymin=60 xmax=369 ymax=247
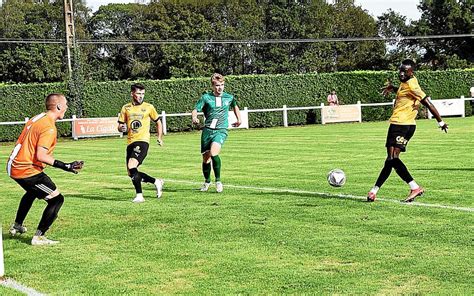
xmin=0 ymin=69 xmax=474 ymax=141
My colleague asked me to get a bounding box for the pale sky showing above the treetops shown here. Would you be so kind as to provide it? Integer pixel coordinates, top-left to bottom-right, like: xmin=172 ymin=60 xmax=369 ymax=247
xmin=86 ymin=0 xmax=421 ymax=20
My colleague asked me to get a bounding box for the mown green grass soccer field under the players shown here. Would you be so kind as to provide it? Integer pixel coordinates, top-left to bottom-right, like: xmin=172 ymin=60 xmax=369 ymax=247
xmin=0 ymin=117 xmax=474 ymax=295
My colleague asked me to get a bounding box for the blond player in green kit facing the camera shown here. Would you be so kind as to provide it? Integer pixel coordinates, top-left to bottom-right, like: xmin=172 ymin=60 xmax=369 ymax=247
xmin=192 ymin=73 xmax=241 ymax=192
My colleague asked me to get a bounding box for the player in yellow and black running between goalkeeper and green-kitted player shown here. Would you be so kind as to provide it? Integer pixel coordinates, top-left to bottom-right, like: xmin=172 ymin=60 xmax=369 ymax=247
xmin=118 ymin=84 xmax=163 ymax=203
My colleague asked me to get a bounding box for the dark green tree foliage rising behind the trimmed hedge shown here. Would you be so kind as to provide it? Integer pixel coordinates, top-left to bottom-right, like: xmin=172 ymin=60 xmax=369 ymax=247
xmin=0 ymin=0 xmax=474 ymax=82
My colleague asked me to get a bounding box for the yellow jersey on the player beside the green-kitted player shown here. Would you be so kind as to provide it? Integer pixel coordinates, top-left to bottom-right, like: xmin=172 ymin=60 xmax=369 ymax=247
xmin=118 ymin=102 xmax=158 ymax=144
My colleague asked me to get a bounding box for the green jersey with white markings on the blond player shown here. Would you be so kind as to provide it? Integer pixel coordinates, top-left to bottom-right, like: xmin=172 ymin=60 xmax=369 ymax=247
xmin=194 ymin=92 xmax=237 ymax=129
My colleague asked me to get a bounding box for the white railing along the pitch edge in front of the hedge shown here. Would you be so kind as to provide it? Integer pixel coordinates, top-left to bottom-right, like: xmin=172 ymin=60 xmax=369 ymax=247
xmin=0 ymin=96 xmax=474 ymax=134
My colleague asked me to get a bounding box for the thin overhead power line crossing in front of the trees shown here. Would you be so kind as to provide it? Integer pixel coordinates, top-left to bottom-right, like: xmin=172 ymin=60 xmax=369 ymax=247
xmin=0 ymin=34 xmax=474 ymax=45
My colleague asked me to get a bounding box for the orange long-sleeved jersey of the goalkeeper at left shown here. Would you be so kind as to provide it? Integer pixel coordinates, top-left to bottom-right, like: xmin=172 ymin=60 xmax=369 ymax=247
xmin=7 ymin=113 xmax=57 ymax=179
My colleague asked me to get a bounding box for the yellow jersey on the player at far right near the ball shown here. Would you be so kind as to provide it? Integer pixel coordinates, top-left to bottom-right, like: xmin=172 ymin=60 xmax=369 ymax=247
xmin=389 ymin=77 xmax=426 ymax=125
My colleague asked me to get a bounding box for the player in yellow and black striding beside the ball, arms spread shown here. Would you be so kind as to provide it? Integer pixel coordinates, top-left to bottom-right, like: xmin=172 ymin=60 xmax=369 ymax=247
xmin=367 ymin=60 xmax=448 ymax=202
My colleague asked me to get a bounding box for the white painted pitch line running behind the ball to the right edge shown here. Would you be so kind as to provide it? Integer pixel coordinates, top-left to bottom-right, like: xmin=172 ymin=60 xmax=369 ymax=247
xmin=165 ymin=179 xmax=474 ymax=212
